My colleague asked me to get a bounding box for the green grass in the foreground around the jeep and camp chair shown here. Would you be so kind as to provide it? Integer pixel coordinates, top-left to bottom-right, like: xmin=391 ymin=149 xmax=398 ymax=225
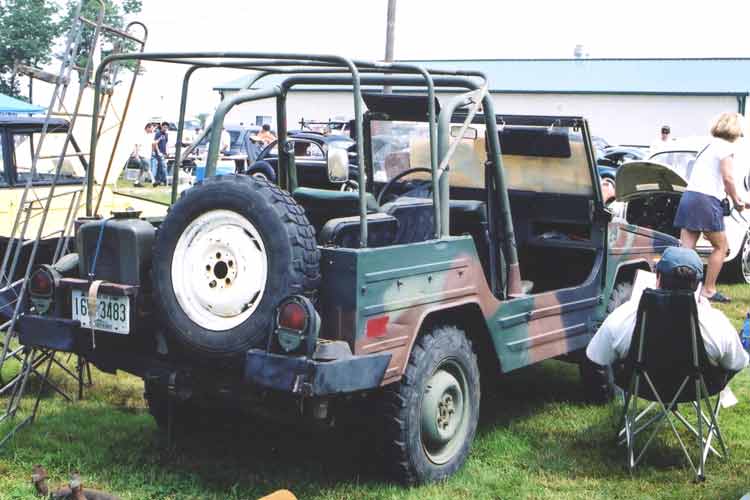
xmin=0 ymin=286 xmax=750 ymax=500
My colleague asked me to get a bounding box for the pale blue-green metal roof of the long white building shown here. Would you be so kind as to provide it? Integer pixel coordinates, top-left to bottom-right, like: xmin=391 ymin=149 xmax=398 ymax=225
xmin=214 ymin=58 xmax=750 ymax=96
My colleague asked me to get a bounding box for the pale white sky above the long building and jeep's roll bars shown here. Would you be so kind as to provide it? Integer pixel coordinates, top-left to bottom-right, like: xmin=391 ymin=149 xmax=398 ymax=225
xmin=119 ymin=0 xmax=750 ymax=119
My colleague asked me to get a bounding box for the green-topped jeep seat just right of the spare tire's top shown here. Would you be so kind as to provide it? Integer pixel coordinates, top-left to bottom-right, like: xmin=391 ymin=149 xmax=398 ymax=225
xmin=292 ymin=187 xmax=378 ymax=234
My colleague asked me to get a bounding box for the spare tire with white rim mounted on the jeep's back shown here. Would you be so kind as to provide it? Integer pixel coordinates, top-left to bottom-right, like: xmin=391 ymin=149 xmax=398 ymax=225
xmin=153 ymin=175 xmax=320 ymax=360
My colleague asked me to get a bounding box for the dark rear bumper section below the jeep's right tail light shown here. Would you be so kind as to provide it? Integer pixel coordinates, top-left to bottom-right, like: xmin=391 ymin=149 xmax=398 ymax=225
xmin=244 ymin=349 xmax=391 ymax=396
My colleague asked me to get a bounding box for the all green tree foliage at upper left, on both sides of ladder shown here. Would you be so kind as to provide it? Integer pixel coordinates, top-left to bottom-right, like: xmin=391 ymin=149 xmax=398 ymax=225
xmin=0 ymin=0 xmax=142 ymax=95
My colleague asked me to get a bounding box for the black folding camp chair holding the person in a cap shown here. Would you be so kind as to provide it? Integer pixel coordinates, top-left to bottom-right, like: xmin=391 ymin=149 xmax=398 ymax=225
xmin=615 ymin=289 xmax=729 ymax=481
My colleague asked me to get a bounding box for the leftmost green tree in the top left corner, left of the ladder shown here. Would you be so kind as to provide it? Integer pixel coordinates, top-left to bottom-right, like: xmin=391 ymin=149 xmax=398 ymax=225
xmin=0 ymin=0 xmax=59 ymax=96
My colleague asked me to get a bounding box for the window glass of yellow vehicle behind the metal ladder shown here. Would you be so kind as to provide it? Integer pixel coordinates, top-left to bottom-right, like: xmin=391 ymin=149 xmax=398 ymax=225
xmin=13 ymin=131 xmax=85 ymax=184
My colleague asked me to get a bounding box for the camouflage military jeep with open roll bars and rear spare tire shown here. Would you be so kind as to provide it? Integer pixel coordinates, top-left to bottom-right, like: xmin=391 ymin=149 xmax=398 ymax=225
xmin=19 ymin=56 xmax=677 ymax=482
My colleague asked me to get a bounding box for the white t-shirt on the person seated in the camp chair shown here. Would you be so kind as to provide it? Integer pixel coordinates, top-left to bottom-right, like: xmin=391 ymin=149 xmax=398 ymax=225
xmin=586 ymin=297 xmax=749 ymax=372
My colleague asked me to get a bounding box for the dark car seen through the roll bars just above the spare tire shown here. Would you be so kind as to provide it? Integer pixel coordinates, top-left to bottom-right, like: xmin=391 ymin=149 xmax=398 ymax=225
xmin=245 ymin=131 xmax=359 ymax=190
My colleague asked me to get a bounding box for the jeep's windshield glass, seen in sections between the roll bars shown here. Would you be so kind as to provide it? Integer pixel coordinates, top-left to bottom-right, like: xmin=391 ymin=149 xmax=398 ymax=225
xmin=371 ymin=120 xmax=593 ymax=196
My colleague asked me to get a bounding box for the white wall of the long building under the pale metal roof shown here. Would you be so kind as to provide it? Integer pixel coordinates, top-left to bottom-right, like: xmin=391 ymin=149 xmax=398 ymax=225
xmin=222 ymin=92 xmax=738 ymax=145
